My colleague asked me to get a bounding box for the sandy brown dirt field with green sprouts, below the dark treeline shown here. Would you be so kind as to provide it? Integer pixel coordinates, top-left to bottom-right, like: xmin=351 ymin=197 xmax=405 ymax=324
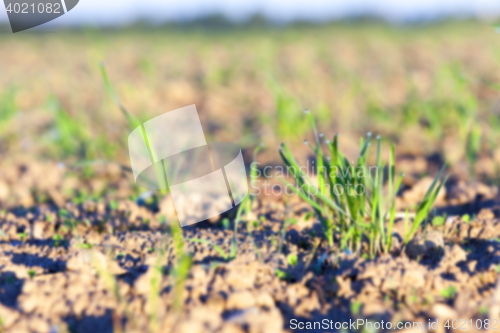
xmin=0 ymin=22 xmax=500 ymax=333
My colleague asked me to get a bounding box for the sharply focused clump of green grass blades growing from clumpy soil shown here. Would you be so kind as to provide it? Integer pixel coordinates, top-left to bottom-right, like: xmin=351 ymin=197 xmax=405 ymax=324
xmin=280 ymin=111 xmax=446 ymax=257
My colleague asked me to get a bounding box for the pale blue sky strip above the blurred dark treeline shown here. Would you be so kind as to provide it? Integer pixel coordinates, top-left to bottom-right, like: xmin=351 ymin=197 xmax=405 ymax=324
xmin=0 ymin=0 xmax=500 ymax=25
